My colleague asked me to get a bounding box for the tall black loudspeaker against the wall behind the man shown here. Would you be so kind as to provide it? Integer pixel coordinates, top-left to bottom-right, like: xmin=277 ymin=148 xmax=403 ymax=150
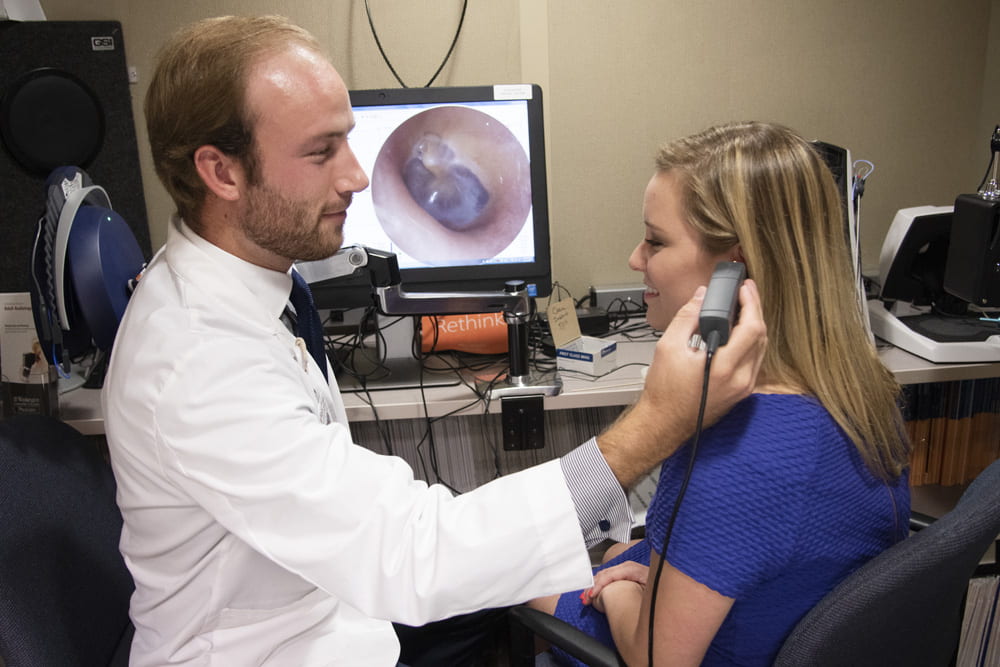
xmin=0 ymin=21 xmax=150 ymax=292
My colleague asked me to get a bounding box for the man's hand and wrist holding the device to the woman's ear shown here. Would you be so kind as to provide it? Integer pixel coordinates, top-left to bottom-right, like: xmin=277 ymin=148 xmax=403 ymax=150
xmin=597 ymin=280 xmax=767 ymax=488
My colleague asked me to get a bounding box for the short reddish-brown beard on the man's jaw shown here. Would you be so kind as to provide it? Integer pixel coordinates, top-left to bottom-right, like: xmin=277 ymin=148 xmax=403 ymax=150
xmin=240 ymin=184 xmax=343 ymax=261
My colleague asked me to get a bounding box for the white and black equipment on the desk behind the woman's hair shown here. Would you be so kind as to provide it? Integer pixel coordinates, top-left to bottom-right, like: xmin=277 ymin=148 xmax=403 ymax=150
xmin=868 ymin=206 xmax=1000 ymax=363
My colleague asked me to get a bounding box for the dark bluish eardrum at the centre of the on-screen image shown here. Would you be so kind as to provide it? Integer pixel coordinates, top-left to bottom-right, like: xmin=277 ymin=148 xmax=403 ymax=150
xmin=403 ymin=133 xmax=490 ymax=232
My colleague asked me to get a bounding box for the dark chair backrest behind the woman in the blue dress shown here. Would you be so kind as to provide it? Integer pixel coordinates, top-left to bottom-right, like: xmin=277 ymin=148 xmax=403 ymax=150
xmin=774 ymin=461 xmax=1000 ymax=667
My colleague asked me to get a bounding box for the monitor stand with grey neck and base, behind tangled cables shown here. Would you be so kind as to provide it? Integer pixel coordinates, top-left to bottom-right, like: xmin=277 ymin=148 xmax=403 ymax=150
xmin=335 ymin=315 xmax=461 ymax=392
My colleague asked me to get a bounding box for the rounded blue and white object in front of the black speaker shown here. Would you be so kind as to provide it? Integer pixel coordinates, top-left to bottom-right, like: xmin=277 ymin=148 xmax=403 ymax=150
xmin=30 ymin=166 xmax=145 ymax=377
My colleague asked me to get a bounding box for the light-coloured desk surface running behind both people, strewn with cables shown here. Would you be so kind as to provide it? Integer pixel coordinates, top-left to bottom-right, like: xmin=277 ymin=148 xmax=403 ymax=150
xmin=59 ymin=341 xmax=1000 ymax=435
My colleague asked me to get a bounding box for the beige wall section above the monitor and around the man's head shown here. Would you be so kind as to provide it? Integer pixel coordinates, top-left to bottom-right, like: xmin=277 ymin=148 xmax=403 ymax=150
xmin=35 ymin=0 xmax=520 ymax=264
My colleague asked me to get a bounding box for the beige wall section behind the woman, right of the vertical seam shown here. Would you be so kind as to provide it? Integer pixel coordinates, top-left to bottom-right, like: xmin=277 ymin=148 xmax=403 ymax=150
xmin=548 ymin=0 xmax=1000 ymax=294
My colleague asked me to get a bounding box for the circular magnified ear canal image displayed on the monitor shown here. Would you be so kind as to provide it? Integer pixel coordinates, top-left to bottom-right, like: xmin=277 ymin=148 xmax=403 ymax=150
xmin=371 ymin=105 xmax=532 ymax=266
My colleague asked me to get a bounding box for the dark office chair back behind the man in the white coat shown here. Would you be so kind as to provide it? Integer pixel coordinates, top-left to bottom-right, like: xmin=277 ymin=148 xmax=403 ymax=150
xmin=0 ymin=415 xmax=134 ymax=667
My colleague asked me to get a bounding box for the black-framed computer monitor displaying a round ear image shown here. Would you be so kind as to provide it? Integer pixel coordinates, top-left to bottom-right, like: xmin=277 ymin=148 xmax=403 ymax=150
xmin=338 ymin=84 xmax=551 ymax=300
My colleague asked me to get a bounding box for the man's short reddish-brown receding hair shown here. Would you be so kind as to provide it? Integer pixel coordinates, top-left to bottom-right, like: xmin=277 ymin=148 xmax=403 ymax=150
xmin=145 ymin=16 xmax=320 ymax=227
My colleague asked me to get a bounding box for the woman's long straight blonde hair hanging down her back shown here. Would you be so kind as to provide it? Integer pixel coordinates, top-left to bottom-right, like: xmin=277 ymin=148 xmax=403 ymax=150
xmin=656 ymin=122 xmax=909 ymax=479
